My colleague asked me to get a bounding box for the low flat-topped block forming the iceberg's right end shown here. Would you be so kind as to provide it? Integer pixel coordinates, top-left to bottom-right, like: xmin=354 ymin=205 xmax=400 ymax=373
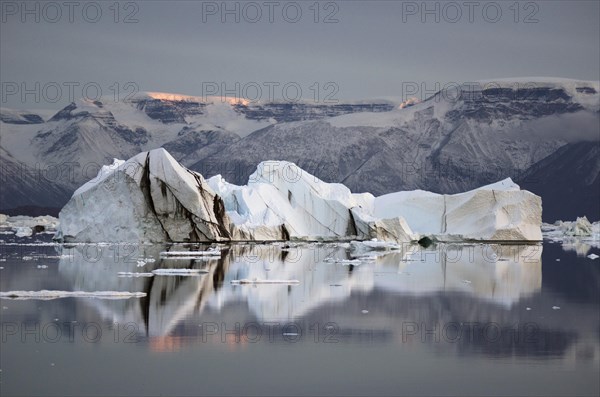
xmin=374 ymin=178 xmax=542 ymax=241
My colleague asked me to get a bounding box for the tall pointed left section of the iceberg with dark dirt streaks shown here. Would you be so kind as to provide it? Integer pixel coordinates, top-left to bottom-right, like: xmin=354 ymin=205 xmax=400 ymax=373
xmin=57 ymin=149 xmax=232 ymax=242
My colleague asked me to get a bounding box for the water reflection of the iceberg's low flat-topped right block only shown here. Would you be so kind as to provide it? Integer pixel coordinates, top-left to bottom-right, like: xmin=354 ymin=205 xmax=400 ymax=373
xmin=375 ymin=245 xmax=542 ymax=305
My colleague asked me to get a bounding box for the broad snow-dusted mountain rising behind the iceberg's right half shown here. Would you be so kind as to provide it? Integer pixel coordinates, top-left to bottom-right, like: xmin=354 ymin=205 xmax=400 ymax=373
xmin=191 ymin=79 xmax=600 ymax=221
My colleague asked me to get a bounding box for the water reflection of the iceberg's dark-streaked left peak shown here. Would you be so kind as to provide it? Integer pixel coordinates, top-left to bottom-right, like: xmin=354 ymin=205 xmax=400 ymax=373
xmin=59 ymin=245 xmax=223 ymax=336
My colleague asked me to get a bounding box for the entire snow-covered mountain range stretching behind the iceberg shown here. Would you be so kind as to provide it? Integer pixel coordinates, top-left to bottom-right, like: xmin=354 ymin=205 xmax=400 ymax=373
xmin=0 ymin=78 xmax=600 ymax=221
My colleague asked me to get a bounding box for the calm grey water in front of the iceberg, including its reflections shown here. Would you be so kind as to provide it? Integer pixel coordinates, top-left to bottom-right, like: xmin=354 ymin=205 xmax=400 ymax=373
xmin=0 ymin=235 xmax=600 ymax=396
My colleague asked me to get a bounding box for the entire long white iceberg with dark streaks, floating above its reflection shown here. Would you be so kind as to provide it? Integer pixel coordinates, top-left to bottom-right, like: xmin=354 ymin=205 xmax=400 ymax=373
xmin=56 ymin=148 xmax=542 ymax=241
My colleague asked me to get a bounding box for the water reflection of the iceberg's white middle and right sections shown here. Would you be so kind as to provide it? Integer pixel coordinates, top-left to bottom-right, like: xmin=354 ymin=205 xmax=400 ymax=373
xmin=207 ymin=241 xmax=542 ymax=319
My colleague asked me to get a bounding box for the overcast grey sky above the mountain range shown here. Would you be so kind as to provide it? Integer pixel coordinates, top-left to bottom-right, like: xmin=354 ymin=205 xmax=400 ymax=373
xmin=0 ymin=1 xmax=600 ymax=109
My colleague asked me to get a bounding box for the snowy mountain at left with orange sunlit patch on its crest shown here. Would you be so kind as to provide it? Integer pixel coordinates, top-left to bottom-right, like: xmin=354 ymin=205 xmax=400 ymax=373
xmin=0 ymin=92 xmax=395 ymax=209
